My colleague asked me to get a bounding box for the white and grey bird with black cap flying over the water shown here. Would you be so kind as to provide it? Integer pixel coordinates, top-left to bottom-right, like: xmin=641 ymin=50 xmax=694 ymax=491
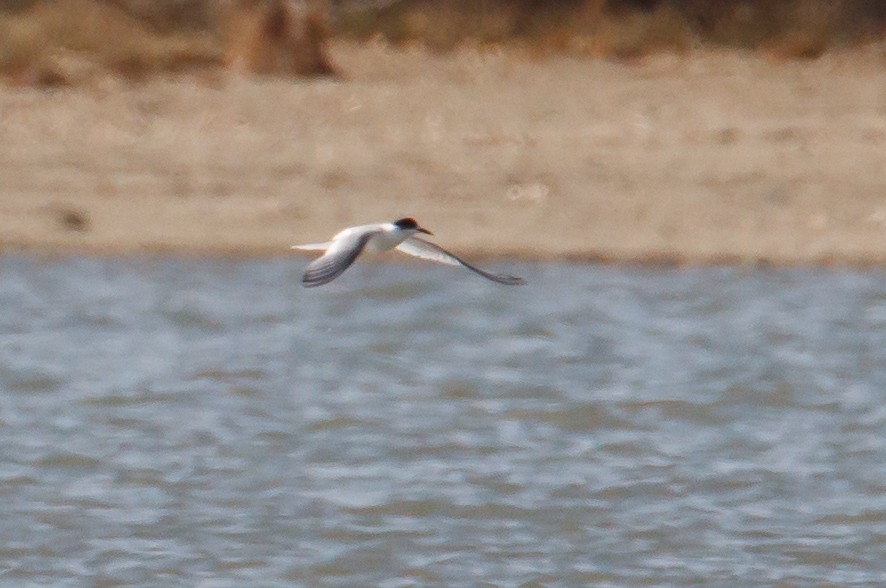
xmin=292 ymin=217 xmax=526 ymax=288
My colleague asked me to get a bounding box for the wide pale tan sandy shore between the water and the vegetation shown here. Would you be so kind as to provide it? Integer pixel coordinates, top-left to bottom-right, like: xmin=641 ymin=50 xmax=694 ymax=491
xmin=0 ymin=42 xmax=886 ymax=264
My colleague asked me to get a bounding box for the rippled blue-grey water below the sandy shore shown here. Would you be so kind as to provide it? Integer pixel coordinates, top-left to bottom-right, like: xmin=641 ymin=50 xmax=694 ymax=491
xmin=0 ymin=257 xmax=886 ymax=587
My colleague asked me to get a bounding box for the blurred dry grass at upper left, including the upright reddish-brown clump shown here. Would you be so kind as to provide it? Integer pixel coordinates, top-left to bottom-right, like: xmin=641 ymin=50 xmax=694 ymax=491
xmin=0 ymin=0 xmax=332 ymax=86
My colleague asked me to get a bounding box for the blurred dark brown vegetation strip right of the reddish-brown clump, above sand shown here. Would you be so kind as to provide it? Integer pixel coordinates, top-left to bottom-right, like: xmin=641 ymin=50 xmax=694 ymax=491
xmin=339 ymin=0 xmax=886 ymax=58
